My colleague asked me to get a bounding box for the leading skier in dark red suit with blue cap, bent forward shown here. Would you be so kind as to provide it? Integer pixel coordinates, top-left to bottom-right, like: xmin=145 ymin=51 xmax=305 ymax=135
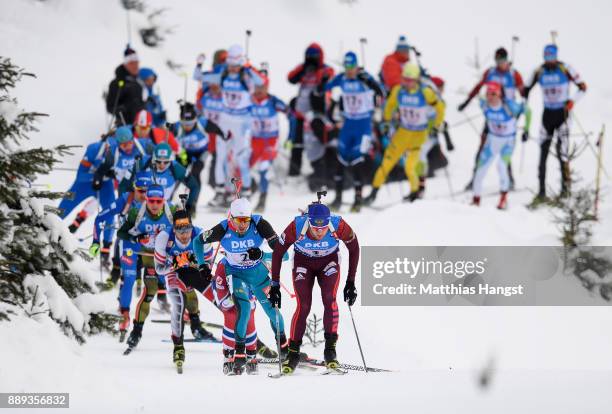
xmin=269 ymin=202 xmax=359 ymax=374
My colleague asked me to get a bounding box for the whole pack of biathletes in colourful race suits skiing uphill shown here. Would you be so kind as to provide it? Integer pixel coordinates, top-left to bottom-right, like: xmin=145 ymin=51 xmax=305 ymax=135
xmin=59 ymin=36 xmax=586 ymax=373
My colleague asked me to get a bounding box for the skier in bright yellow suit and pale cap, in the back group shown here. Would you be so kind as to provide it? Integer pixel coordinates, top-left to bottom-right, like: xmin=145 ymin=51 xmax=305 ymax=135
xmin=364 ymin=63 xmax=444 ymax=204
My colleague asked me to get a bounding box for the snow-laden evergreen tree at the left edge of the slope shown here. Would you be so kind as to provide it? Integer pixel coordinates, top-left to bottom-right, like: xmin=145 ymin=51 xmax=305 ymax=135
xmin=0 ymin=57 xmax=116 ymax=343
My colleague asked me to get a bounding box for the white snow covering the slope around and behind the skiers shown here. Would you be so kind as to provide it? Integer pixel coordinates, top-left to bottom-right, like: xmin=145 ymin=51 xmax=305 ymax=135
xmin=0 ymin=0 xmax=612 ymax=413
